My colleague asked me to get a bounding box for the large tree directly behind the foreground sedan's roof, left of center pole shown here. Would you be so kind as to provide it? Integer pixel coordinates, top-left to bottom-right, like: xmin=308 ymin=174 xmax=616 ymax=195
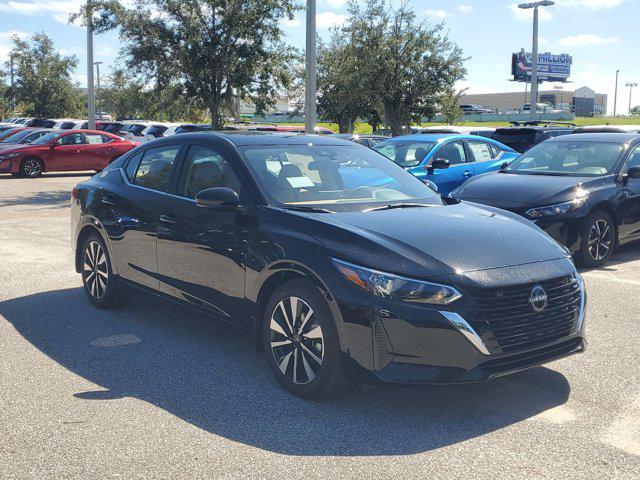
xmin=74 ymin=0 xmax=297 ymax=128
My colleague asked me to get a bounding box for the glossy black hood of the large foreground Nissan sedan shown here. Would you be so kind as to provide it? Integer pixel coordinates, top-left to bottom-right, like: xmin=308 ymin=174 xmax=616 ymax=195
xmin=282 ymin=203 xmax=567 ymax=278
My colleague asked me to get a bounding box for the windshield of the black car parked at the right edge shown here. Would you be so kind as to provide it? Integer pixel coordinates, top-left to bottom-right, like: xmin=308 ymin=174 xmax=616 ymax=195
xmin=505 ymin=141 xmax=624 ymax=177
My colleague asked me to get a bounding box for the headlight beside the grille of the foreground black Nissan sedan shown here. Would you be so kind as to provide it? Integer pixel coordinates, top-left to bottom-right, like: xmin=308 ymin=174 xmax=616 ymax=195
xmin=333 ymin=258 xmax=462 ymax=305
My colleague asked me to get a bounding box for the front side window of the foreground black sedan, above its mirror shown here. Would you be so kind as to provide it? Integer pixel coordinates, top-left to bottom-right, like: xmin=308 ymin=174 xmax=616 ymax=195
xmin=178 ymin=145 xmax=241 ymax=198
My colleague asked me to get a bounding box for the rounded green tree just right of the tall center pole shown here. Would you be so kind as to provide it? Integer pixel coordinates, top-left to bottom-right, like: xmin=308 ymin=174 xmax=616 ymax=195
xmin=318 ymin=0 xmax=466 ymax=134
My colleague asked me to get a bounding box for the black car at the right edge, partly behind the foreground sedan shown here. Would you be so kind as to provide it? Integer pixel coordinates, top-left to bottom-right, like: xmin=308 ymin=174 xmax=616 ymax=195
xmin=450 ymin=133 xmax=640 ymax=268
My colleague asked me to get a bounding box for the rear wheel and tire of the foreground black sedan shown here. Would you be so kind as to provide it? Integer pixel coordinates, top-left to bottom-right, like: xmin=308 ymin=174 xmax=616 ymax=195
xmin=80 ymin=233 xmax=126 ymax=308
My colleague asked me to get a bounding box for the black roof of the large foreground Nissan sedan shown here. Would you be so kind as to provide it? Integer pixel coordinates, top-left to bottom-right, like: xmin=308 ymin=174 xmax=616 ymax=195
xmin=166 ymin=130 xmax=354 ymax=146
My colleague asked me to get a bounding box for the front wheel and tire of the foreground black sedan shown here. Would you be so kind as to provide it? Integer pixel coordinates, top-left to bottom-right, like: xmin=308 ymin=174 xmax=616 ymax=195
xmin=262 ymin=280 xmax=351 ymax=399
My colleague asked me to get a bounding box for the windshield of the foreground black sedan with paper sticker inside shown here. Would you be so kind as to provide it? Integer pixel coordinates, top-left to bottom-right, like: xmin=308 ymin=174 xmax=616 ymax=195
xmin=241 ymin=144 xmax=442 ymax=211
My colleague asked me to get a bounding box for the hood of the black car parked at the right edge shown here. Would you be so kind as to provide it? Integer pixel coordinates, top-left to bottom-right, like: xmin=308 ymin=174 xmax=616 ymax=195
xmin=451 ymin=173 xmax=608 ymax=209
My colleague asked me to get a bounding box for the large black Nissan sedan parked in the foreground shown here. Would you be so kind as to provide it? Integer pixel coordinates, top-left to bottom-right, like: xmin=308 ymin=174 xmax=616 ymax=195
xmin=71 ymin=132 xmax=586 ymax=398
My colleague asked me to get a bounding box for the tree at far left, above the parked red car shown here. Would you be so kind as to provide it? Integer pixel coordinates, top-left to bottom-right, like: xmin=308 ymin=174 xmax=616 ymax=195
xmin=11 ymin=33 xmax=84 ymax=118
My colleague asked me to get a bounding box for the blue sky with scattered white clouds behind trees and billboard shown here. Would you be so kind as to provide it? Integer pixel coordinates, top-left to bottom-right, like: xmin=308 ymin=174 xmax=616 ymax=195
xmin=0 ymin=0 xmax=640 ymax=112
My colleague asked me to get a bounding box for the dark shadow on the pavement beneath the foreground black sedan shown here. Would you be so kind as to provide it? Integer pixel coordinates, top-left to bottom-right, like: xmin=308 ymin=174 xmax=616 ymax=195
xmin=0 ymin=288 xmax=570 ymax=456
